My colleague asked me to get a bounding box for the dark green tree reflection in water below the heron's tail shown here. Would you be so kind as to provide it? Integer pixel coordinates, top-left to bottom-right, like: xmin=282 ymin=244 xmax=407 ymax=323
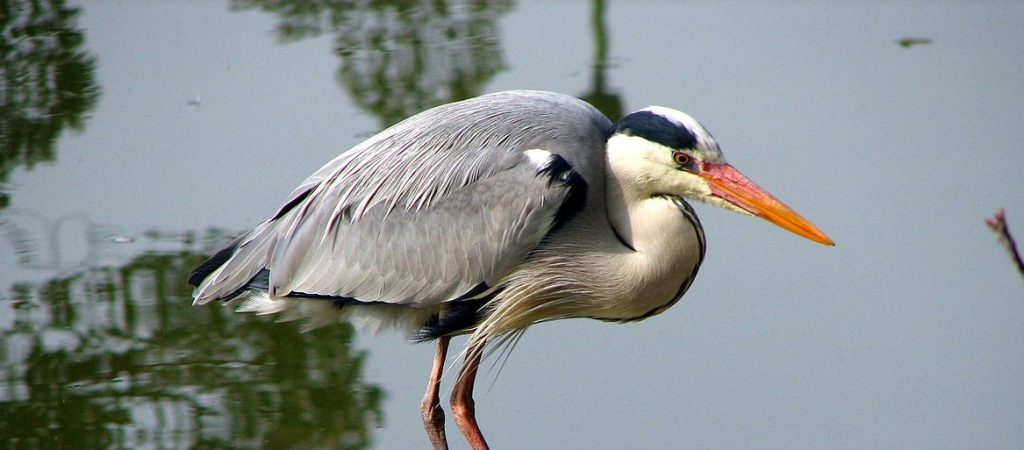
xmin=0 ymin=230 xmax=384 ymax=449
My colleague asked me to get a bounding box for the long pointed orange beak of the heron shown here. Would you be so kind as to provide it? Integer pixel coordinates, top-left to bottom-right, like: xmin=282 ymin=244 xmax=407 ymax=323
xmin=700 ymin=163 xmax=836 ymax=245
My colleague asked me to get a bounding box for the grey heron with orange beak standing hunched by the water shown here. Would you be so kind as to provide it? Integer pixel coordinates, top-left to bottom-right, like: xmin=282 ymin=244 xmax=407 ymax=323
xmin=188 ymin=91 xmax=834 ymax=449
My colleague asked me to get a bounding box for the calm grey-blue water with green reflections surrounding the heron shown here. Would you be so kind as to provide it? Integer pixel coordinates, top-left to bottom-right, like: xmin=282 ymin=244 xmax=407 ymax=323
xmin=0 ymin=1 xmax=1024 ymax=449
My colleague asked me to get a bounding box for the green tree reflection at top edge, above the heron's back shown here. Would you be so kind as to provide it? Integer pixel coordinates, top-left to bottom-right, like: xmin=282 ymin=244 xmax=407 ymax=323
xmin=230 ymin=0 xmax=513 ymax=128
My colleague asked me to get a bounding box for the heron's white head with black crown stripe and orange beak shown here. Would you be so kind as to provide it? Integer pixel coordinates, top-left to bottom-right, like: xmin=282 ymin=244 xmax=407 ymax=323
xmin=607 ymin=107 xmax=835 ymax=245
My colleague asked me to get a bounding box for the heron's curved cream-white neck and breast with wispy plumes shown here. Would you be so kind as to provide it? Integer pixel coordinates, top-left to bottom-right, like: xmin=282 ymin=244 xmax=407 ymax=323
xmin=468 ymin=137 xmax=703 ymax=333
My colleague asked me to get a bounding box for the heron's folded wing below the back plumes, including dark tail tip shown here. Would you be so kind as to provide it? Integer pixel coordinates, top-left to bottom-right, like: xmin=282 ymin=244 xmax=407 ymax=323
xmin=196 ymin=145 xmax=586 ymax=304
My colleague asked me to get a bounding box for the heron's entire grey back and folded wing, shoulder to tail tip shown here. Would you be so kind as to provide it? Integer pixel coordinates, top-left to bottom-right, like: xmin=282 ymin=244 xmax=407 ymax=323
xmin=189 ymin=91 xmax=610 ymax=305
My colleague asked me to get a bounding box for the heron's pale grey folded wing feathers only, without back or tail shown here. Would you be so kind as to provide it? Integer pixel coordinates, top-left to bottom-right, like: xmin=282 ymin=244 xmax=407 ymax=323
xmin=268 ymin=146 xmax=573 ymax=304
